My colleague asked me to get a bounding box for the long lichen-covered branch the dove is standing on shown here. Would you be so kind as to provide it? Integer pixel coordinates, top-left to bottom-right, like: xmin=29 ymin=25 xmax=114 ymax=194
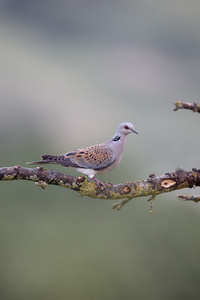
xmin=0 ymin=166 xmax=200 ymax=210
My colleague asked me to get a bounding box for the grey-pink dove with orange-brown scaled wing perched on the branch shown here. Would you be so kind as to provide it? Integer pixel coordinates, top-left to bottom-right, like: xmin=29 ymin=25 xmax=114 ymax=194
xmin=27 ymin=122 xmax=138 ymax=187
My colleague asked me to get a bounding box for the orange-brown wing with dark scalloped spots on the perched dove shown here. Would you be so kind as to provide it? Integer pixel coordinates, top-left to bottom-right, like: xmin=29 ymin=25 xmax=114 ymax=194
xmin=62 ymin=144 xmax=115 ymax=170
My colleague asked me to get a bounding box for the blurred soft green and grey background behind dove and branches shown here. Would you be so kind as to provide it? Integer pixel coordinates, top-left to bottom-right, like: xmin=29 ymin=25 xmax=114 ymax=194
xmin=0 ymin=0 xmax=200 ymax=300
